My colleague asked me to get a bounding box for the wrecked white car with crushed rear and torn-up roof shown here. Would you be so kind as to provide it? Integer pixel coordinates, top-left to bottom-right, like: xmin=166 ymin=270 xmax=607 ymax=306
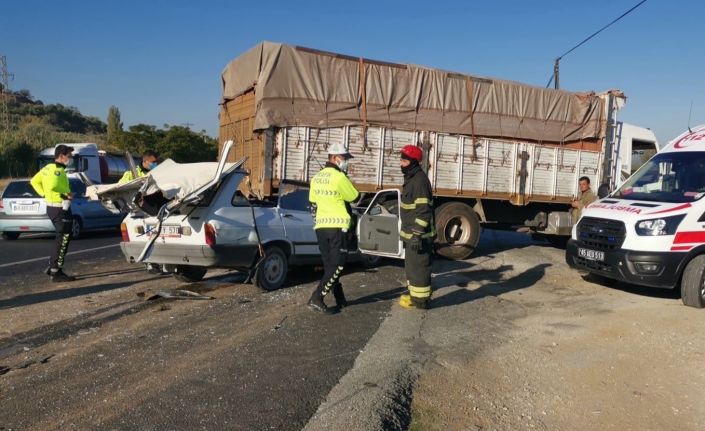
xmin=94 ymin=142 xmax=374 ymax=290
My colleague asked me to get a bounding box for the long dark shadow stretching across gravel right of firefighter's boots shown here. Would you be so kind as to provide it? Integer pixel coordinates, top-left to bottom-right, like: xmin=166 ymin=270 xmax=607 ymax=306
xmin=431 ymin=263 xmax=551 ymax=308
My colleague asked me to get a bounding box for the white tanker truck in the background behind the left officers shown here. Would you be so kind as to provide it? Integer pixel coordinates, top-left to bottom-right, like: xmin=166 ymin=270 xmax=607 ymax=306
xmin=38 ymin=143 xmax=139 ymax=184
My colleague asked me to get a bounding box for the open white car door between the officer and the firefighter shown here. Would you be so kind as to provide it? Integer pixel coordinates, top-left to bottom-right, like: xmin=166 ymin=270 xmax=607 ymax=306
xmin=357 ymin=190 xmax=404 ymax=259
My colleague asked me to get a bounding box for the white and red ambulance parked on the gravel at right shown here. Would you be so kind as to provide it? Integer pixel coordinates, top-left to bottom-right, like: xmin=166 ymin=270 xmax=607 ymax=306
xmin=566 ymin=125 xmax=705 ymax=308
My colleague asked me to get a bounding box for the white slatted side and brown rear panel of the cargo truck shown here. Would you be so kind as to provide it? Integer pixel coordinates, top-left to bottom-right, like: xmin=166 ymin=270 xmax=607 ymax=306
xmin=220 ymin=91 xmax=602 ymax=205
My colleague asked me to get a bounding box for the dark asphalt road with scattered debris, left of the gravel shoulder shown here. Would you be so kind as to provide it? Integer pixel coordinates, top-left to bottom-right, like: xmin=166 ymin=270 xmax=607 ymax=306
xmin=0 ymin=235 xmax=402 ymax=430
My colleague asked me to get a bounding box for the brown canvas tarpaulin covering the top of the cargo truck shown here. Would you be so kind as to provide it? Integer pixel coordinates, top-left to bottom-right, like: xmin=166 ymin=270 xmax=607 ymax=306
xmin=221 ymin=42 xmax=606 ymax=142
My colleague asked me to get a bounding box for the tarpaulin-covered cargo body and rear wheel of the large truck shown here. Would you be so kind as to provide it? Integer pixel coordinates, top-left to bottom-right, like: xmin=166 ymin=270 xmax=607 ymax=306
xmin=219 ymin=42 xmax=626 ymax=259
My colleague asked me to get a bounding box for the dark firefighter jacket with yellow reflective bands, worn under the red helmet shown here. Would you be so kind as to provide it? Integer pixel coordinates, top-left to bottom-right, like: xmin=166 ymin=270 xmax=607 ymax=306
xmin=399 ymin=164 xmax=436 ymax=241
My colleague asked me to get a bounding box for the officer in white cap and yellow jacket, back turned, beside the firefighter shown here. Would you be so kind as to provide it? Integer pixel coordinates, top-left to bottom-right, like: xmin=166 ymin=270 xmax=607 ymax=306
xmin=308 ymin=144 xmax=359 ymax=314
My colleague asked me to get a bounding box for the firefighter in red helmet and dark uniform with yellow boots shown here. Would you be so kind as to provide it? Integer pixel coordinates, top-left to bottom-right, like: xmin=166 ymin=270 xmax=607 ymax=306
xmin=399 ymin=145 xmax=436 ymax=309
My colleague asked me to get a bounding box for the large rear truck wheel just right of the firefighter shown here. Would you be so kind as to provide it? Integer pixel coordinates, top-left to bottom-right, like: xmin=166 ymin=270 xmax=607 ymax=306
xmin=436 ymin=202 xmax=480 ymax=260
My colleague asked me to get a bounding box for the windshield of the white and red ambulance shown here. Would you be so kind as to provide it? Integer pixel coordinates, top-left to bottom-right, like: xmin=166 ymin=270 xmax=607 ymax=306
xmin=612 ymin=151 xmax=705 ymax=203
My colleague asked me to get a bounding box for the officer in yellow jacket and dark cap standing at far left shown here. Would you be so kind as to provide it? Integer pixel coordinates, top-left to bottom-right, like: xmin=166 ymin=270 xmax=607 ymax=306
xmin=31 ymin=144 xmax=76 ymax=283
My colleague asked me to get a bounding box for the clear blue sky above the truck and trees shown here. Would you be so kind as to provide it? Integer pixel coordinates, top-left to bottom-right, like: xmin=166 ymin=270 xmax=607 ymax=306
xmin=0 ymin=0 xmax=705 ymax=145
